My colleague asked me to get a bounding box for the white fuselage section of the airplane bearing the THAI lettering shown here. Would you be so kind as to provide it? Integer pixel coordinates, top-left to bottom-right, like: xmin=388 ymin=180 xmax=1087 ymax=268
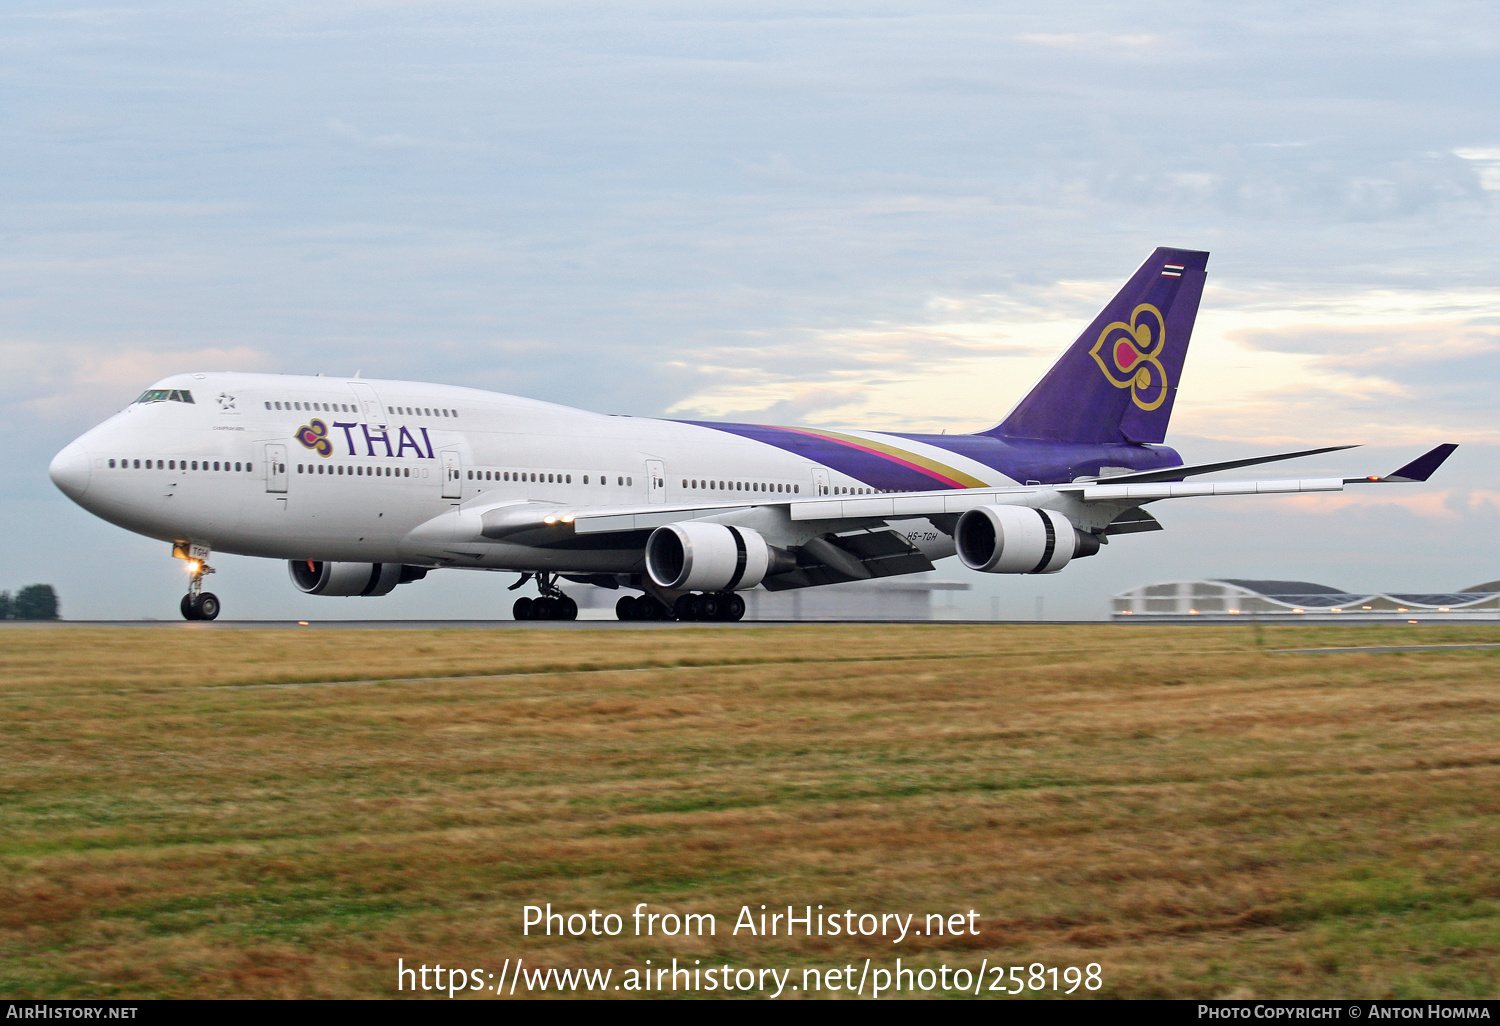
xmin=53 ymin=374 xmax=984 ymax=573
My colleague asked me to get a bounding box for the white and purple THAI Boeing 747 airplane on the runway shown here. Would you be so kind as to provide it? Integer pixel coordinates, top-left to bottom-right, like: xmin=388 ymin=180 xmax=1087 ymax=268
xmin=50 ymin=249 xmax=1455 ymax=620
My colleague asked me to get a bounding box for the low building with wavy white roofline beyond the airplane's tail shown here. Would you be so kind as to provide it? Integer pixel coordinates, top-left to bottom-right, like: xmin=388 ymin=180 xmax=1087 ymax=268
xmin=1112 ymin=578 xmax=1500 ymax=621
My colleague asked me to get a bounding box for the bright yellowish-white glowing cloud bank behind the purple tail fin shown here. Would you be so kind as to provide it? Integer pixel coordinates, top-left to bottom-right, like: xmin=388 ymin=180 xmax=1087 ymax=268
xmin=669 ymin=282 xmax=1500 ymax=446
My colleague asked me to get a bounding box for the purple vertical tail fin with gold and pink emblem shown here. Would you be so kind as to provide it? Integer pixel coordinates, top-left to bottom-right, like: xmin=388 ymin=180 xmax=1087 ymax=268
xmin=984 ymin=249 xmax=1209 ymax=443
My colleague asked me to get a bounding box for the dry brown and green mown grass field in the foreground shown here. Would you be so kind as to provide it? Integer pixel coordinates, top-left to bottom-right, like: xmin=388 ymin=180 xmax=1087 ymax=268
xmin=0 ymin=624 xmax=1500 ymax=999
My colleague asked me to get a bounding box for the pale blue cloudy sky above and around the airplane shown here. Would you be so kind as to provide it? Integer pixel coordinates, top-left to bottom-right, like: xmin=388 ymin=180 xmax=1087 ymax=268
xmin=0 ymin=0 xmax=1500 ymax=620
